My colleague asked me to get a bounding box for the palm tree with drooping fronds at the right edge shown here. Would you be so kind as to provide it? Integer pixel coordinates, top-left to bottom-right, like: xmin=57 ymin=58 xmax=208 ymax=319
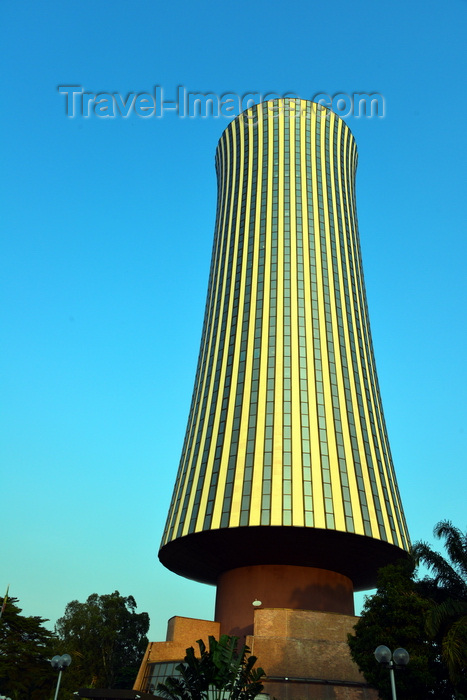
xmin=413 ymin=520 xmax=467 ymax=692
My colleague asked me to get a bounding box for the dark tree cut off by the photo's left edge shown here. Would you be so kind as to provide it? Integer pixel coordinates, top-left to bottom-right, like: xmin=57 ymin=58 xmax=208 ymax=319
xmin=0 ymin=598 xmax=57 ymax=700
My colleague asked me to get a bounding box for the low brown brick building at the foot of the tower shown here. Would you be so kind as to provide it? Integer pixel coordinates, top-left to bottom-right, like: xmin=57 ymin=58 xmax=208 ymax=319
xmin=134 ymin=608 xmax=378 ymax=700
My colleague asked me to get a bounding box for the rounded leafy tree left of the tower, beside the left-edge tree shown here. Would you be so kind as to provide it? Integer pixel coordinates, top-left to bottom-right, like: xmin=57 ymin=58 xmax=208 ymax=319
xmin=55 ymin=591 xmax=149 ymax=690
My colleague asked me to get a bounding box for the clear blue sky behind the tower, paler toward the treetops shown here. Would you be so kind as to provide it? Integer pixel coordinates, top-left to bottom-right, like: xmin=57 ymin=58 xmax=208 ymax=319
xmin=0 ymin=0 xmax=467 ymax=641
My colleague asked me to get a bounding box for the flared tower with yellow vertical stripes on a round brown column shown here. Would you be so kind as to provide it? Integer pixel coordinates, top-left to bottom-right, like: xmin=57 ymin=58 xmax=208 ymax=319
xmin=159 ymin=99 xmax=409 ymax=634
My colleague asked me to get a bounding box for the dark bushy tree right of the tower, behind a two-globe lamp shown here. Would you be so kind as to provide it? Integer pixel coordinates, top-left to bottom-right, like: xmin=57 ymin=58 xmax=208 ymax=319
xmin=348 ymin=561 xmax=454 ymax=700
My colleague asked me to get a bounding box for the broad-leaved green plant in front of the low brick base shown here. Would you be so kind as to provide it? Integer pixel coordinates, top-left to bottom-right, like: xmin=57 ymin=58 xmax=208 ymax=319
xmin=157 ymin=634 xmax=265 ymax=700
